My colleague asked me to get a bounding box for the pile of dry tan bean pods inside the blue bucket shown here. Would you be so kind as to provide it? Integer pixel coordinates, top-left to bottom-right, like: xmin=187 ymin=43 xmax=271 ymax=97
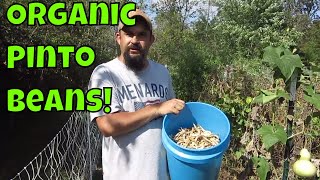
xmin=173 ymin=124 xmax=220 ymax=149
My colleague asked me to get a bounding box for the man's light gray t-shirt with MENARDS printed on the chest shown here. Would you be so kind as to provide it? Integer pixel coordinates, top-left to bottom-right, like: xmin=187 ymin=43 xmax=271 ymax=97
xmin=89 ymin=58 xmax=175 ymax=180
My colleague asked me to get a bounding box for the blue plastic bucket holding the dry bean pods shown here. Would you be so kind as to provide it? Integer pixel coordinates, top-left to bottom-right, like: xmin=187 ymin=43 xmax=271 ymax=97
xmin=162 ymin=102 xmax=230 ymax=180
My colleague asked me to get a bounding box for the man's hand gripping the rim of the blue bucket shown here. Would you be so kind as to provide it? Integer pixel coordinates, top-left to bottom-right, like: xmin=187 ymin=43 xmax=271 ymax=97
xmin=157 ymin=99 xmax=185 ymax=116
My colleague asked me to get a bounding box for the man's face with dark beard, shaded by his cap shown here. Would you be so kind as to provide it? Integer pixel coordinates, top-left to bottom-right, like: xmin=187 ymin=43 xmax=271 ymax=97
xmin=116 ymin=18 xmax=154 ymax=72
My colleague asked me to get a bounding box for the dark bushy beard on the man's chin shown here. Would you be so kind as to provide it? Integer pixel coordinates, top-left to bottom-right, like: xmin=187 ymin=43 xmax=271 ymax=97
xmin=123 ymin=49 xmax=145 ymax=72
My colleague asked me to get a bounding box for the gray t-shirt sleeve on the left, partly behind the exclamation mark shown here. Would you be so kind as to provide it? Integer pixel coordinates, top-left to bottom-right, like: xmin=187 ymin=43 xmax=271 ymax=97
xmin=88 ymin=67 xmax=122 ymax=121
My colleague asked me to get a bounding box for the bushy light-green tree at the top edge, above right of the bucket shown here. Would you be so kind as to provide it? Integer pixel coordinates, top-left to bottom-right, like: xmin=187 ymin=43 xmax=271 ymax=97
xmin=215 ymin=0 xmax=301 ymax=57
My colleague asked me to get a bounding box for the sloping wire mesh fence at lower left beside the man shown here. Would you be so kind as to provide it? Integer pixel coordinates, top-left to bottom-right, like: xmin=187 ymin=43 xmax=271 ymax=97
xmin=11 ymin=112 xmax=101 ymax=180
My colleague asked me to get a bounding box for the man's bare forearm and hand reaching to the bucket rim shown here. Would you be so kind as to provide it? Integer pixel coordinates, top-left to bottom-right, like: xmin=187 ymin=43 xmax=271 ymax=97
xmin=96 ymin=99 xmax=185 ymax=137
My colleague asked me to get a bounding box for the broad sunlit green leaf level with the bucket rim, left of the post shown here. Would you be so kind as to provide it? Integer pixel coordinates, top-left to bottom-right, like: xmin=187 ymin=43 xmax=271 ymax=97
xmin=258 ymin=125 xmax=287 ymax=150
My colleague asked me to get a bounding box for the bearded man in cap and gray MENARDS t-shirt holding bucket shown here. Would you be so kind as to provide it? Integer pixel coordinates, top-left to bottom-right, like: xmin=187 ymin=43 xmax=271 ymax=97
xmin=89 ymin=9 xmax=185 ymax=180
